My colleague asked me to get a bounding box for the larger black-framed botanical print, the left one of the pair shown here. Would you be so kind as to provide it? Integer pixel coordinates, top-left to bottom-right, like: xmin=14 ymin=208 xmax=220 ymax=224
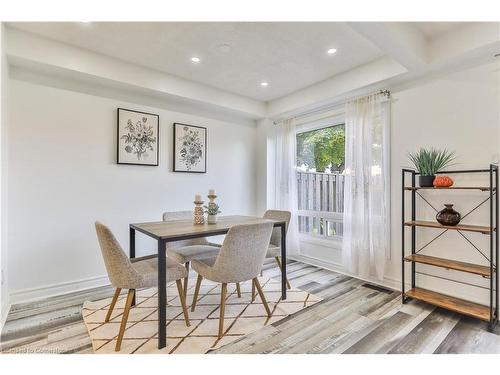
xmin=117 ymin=108 xmax=160 ymax=166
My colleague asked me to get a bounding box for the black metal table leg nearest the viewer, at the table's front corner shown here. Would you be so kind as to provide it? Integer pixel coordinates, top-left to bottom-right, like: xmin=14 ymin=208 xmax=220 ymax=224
xmin=158 ymin=240 xmax=167 ymax=349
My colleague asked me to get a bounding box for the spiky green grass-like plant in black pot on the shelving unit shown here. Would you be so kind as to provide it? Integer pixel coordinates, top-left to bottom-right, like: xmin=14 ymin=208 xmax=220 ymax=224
xmin=408 ymin=148 xmax=455 ymax=187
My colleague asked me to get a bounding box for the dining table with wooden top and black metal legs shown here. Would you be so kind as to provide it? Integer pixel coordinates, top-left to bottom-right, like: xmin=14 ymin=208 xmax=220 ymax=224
xmin=129 ymin=215 xmax=286 ymax=349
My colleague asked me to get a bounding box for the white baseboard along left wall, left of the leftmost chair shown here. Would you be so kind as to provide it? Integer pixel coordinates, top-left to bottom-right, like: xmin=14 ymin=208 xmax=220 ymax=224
xmin=10 ymin=276 xmax=110 ymax=305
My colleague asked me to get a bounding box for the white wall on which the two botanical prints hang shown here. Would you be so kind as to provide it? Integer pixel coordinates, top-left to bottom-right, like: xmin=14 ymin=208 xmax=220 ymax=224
xmin=8 ymin=80 xmax=257 ymax=301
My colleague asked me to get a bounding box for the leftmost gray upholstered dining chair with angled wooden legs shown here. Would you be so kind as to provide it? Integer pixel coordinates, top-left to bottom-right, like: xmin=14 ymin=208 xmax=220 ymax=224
xmin=95 ymin=222 xmax=190 ymax=351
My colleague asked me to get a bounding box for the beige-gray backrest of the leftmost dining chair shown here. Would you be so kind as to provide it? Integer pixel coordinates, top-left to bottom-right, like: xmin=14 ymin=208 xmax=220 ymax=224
xmin=95 ymin=221 xmax=140 ymax=288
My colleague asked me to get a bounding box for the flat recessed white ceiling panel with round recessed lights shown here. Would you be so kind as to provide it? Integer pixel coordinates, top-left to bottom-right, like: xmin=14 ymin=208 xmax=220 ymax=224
xmin=9 ymin=22 xmax=384 ymax=101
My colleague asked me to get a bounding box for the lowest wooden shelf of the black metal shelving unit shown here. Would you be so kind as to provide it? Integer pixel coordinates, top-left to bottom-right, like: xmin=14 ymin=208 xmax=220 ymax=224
xmin=405 ymin=288 xmax=490 ymax=322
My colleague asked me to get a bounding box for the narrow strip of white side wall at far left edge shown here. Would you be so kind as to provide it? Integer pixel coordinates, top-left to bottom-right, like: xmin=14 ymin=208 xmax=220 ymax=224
xmin=0 ymin=23 xmax=9 ymax=330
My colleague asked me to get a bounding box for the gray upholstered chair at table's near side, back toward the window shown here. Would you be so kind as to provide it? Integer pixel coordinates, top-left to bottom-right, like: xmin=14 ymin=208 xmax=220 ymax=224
xmin=191 ymin=221 xmax=273 ymax=338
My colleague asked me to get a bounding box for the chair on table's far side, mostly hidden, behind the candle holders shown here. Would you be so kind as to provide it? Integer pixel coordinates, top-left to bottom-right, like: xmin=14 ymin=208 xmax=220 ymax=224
xmin=163 ymin=211 xmax=220 ymax=296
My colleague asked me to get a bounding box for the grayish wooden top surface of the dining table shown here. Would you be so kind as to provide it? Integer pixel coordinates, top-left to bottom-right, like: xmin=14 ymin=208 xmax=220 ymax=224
xmin=130 ymin=215 xmax=284 ymax=240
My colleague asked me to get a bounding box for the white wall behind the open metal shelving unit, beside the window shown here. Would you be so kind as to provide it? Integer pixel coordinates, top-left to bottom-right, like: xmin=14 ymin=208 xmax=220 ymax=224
xmin=267 ymin=62 xmax=500 ymax=303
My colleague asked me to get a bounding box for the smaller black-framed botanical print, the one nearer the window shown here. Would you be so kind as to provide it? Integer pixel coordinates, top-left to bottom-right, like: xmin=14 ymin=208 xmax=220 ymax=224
xmin=174 ymin=122 xmax=207 ymax=173
